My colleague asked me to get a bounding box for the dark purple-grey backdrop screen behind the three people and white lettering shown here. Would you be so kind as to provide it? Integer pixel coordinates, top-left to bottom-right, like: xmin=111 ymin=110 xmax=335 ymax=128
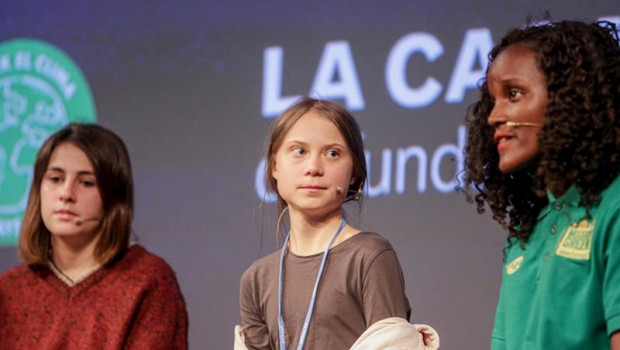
xmin=0 ymin=0 xmax=620 ymax=349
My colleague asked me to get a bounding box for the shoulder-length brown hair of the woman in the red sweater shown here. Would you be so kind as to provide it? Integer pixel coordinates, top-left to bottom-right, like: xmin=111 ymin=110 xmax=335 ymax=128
xmin=18 ymin=124 xmax=133 ymax=266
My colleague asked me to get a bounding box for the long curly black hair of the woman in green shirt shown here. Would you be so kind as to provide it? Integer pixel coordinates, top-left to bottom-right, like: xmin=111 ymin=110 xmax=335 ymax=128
xmin=459 ymin=21 xmax=620 ymax=245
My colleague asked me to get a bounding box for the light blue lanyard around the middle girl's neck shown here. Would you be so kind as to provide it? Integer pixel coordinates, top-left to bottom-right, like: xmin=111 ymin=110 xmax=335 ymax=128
xmin=278 ymin=218 xmax=347 ymax=350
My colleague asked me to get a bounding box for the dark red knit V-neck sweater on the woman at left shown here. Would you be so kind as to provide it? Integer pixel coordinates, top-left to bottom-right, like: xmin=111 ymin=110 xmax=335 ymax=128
xmin=0 ymin=245 xmax=187 ymax=350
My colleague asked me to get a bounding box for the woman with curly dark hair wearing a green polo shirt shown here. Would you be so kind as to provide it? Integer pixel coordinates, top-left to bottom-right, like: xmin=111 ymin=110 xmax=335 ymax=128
xmin=462 ymin=21 xmax=620 ymax=350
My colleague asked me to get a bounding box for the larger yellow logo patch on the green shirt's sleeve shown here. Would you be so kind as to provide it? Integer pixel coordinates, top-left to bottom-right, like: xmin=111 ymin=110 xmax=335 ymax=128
xmin=555 ymin=220 xmax=594 ymax=260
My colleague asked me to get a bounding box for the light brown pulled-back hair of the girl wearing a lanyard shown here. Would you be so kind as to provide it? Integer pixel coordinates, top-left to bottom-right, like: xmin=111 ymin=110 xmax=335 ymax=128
xmin=265 ymin=97 xmax=367 ymax=213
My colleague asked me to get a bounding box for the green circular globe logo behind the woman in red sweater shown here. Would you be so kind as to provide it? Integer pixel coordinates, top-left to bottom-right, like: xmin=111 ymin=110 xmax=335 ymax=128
xmin=0 ymin=39 xmax=95 ymax=246
